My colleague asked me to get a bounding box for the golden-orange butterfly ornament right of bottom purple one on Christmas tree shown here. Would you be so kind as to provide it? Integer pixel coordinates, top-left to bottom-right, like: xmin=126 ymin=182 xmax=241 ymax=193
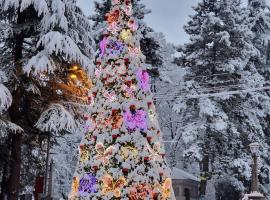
xmin=102 ymin=174 xmax=127 ymax=198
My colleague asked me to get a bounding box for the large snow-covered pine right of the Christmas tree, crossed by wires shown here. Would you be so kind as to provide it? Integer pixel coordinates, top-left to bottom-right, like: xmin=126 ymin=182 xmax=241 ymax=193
xmin=177 ymin=0 xmax=269 ymax=199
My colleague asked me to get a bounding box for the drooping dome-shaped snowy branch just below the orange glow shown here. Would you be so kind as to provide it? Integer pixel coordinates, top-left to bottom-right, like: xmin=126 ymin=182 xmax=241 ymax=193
xmin=35 ymin=104 xmax=76 ymax=134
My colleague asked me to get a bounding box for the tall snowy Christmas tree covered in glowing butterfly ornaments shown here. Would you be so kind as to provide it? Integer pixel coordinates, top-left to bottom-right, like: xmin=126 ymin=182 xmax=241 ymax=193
xmin=69 ymin=0 xmax=175 ymax=200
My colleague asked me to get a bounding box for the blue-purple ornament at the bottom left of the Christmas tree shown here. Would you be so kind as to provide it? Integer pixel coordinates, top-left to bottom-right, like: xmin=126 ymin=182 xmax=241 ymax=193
xmin=79 ymin=173 xmax=98 ymax=196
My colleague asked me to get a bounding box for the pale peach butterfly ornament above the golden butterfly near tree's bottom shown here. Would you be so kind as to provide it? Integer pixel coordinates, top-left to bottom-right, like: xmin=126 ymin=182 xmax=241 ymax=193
xmin=95 ymin=143 xmax=115 ymax=165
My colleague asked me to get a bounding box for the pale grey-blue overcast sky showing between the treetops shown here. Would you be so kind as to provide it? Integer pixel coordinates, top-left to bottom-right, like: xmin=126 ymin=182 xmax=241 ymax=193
xmin=77 ymin=0 xmax=270 ymax=44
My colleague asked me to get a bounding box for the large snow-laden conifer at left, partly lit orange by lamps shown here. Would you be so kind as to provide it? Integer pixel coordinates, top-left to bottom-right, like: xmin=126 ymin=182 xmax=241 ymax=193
xmin=0 ymin=0 xmax=93 ymax=199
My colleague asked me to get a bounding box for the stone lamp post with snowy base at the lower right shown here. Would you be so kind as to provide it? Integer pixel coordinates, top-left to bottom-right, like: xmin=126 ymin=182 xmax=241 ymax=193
xmin=243 ymin=142 xmax=265 ymax=200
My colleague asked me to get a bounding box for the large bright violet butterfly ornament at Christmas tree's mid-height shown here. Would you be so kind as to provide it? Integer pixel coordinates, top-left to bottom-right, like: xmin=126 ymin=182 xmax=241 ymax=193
xmin=124 ymin=109 xmax=148 ymax=131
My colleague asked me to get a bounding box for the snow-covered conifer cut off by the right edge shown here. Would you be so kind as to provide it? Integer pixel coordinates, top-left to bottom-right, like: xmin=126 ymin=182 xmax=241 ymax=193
xmin=244 ymin=0 xmax=270 ymax=198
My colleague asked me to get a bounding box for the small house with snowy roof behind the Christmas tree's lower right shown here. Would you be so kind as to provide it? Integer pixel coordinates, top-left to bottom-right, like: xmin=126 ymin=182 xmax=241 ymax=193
xmin=172 ymin=167 xmax=200 ymax=200
